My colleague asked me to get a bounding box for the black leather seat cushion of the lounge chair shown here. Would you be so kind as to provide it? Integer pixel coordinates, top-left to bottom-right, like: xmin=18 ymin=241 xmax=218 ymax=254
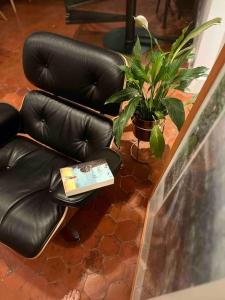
xmin=0 ymin=137 xmax=74 ymax=257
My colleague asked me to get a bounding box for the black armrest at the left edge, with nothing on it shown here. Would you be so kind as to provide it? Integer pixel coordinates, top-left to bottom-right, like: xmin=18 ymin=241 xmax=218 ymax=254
xmin=0 ymin=103 xmax=20 ymax=144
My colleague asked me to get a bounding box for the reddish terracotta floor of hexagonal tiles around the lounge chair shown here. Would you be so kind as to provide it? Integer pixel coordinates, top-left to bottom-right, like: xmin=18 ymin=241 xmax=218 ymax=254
xmin=0 ymin=0 xmax=192 ymax=300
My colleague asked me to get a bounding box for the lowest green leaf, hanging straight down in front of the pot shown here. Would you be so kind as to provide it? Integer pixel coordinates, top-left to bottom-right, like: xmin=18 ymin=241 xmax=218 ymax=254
xmin=150 ymin=125 xmax=165 ymax=158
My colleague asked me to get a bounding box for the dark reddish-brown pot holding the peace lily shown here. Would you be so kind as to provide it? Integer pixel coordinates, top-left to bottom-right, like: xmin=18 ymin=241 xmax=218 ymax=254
xmin=132 ymin=114 xmax=165 ymax=142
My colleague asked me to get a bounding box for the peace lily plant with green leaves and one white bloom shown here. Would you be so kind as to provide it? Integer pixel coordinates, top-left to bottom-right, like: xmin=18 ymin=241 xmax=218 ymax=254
xmin=106 ymin=16 xmax=221 ymax=157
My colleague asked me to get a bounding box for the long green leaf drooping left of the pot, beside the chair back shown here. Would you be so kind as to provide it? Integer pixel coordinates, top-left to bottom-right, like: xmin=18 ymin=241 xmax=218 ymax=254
xmin=113 ymin=96 xmax=141 ymax=147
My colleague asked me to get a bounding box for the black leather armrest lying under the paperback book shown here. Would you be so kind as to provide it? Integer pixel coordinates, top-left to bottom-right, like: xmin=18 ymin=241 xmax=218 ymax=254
xmin=52 ymin=148 xmax=121 ymax=207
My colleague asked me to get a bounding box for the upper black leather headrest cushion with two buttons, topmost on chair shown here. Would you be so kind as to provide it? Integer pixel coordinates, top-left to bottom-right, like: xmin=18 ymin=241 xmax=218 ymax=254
xmin=23 ymin=32 xmax=124 ymax=115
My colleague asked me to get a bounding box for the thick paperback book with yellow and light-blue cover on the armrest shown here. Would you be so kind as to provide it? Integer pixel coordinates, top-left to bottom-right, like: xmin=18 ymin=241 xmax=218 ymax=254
xmin=60 ymin=159 xmax=114 ymax=197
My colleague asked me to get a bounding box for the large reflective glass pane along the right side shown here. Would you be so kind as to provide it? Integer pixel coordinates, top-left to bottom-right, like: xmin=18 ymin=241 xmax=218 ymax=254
xmin=132 ymin=54 xmax=225 ymax=300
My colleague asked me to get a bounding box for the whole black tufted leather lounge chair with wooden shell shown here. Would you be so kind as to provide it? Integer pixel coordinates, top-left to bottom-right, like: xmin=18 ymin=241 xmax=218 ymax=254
xmin=0 ymin=32 xmax=124 ymax=258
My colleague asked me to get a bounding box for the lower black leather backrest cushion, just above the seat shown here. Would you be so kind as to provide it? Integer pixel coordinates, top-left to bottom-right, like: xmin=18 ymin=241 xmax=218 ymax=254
xmin=20 ymin=91 xmax=112 ymax=161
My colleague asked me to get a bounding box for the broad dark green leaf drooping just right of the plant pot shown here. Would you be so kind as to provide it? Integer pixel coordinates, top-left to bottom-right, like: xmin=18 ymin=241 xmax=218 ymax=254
xmin=164 ymin=98 xmax=185 ymax=130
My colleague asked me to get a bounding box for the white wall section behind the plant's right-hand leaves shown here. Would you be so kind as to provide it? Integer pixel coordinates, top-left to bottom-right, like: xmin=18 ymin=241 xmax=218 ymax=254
xmin=189 ymin=0 xmax=225 ymax=93
